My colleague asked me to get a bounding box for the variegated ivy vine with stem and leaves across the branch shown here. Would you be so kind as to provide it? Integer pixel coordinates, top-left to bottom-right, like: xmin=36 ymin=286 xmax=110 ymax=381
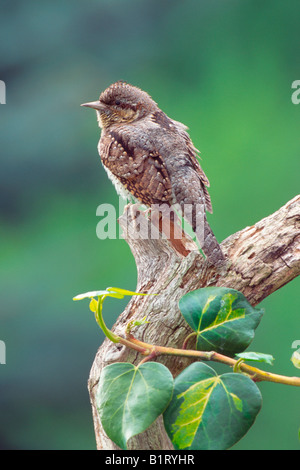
xmin=74 ymin=287 xmax=300 ymax=450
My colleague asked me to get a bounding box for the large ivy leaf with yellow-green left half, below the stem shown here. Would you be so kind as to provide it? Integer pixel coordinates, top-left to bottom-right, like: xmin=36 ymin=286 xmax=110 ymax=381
xmin=164 ymin=362 xmax=262 ymax=450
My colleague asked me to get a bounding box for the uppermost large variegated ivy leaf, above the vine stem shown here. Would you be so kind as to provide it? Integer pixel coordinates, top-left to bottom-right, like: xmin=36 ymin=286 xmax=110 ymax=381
xmin=179 ymin=287 xmax=264 ymax=356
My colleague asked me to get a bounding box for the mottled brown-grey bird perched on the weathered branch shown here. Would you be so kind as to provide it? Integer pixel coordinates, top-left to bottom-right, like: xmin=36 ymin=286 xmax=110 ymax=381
xmin=81 ymin=80 xmax=225 ymax=266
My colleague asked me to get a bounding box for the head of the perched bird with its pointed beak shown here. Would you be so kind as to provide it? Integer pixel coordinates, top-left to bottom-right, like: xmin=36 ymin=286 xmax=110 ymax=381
xmin=81 ymin=81 xmax=157 ymax=128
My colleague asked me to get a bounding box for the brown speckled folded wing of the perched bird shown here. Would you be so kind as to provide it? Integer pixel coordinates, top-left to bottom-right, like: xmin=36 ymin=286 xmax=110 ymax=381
xmin=99 ymin=131 xmax=172 ymax=206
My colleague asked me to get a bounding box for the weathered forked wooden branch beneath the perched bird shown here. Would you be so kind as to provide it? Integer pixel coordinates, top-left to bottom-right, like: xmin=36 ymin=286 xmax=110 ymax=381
xmin=89 ymin=196 xmax=300 ymax=450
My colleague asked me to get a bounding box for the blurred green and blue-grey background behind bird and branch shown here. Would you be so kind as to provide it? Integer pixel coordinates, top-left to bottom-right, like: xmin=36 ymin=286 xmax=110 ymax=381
xmin=0 ymin=0 xmax=300 ymax=449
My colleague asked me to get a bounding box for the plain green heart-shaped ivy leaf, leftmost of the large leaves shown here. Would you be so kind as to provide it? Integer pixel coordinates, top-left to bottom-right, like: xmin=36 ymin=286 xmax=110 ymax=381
xmin=96 ymin=362 xmax=174 ymax=449
